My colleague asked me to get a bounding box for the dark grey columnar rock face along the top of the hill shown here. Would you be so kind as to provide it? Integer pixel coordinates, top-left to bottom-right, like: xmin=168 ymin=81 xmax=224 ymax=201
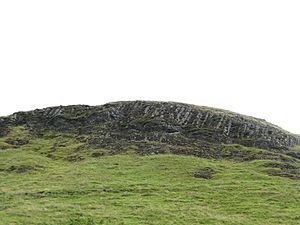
xmin=0 ymin=101 xmax=300 ymax=151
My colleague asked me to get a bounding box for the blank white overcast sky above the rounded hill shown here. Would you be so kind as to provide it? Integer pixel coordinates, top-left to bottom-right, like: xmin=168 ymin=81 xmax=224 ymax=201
xmin=0 ymin=0 xmax=300 ymax=133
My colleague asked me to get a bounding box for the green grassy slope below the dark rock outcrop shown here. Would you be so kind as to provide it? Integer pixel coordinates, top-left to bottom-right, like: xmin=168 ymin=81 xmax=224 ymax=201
xmin=0 ymin=127 xmax=300 ymax=225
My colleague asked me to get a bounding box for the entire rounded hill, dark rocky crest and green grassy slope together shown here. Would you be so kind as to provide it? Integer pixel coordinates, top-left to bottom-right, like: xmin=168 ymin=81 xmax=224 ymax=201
xmin=0 ymin=101 xmax=300 ymax=224
